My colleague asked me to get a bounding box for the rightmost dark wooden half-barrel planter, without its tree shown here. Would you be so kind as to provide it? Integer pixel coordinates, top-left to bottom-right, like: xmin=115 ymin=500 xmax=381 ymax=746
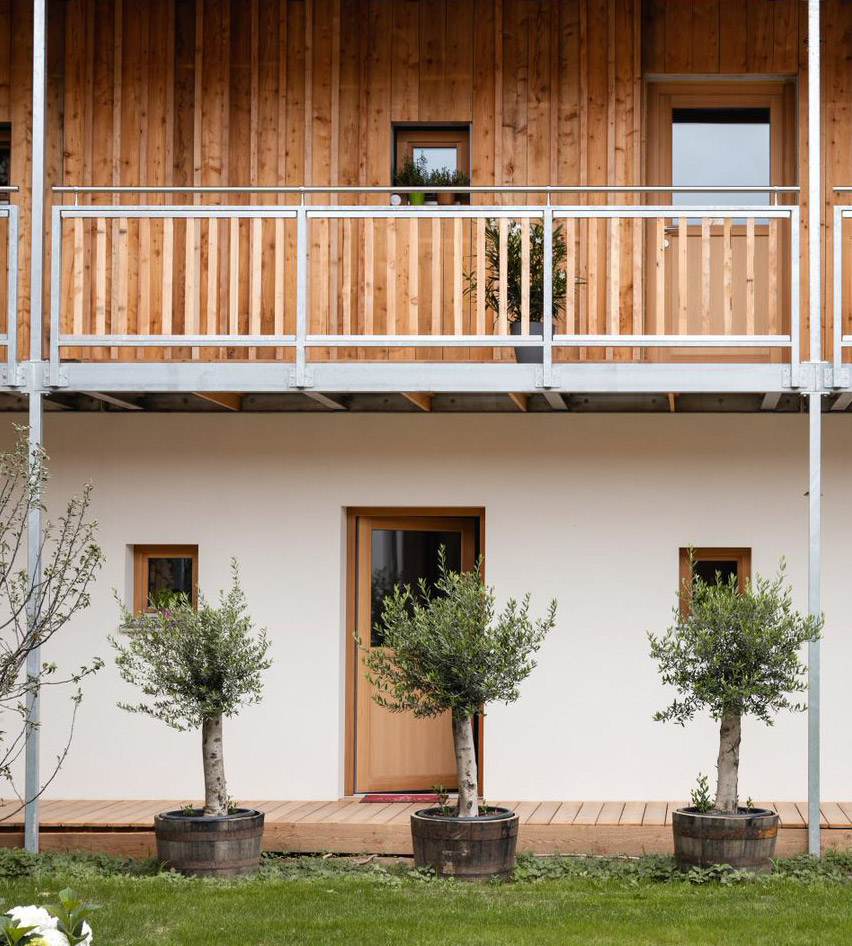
xmin=672 ymin=808 xmax=778 ymax=871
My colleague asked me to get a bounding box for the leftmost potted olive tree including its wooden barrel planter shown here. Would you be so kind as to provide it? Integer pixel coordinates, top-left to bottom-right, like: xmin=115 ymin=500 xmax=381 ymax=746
xmin=110 ymin=561 xmax=270 ymax=876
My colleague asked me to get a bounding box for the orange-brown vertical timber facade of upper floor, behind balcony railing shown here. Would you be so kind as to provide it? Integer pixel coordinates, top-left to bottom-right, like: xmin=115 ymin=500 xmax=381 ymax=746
xmin=0 ymin=0 xmax=852 ymax=360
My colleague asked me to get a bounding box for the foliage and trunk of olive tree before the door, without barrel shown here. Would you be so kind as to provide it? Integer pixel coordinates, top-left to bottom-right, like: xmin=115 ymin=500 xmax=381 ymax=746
xmin=363 ymin=548 xmax=556 ymax=818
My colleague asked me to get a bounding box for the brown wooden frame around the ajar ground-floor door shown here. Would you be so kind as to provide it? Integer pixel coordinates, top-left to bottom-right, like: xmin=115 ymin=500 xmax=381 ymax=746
xmin=343 ymin=506 xmax=485 ymax=795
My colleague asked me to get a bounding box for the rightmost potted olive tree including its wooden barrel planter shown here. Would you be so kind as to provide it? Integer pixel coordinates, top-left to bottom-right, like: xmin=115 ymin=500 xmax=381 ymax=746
xmin=648 ymin=561 xmax=822 ymax=871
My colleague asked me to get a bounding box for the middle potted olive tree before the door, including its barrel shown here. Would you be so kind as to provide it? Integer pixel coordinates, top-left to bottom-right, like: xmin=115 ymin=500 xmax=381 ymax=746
xmin=363 ymin=548 xmax=556 ymax=880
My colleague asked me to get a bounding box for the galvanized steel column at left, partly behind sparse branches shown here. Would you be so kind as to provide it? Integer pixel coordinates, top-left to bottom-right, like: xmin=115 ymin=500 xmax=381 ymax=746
xmin=24 ymin=0 xmax=47 ymax=851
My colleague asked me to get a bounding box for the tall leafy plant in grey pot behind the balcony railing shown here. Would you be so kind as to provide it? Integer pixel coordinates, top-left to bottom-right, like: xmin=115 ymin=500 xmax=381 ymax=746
xmin=465 ymin=220 xmax=568 ymax=364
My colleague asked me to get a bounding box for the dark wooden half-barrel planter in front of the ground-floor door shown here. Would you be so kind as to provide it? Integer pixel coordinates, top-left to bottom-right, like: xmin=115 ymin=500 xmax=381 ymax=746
xmin=411 ymin=808 xmax=518 ymax=883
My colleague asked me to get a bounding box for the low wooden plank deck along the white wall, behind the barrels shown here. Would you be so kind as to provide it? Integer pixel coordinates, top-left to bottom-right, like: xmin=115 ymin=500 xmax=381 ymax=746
xmin=5 ymin=798 xmax=852 ymax=856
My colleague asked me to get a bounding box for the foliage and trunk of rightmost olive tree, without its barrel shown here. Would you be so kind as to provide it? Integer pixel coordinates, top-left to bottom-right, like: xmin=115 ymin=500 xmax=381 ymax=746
xmin=648 ymin=560 xmax=822 ymax=813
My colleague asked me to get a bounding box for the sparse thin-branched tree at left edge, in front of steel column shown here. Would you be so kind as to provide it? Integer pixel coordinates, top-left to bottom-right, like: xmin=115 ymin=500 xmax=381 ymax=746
xmin=0 ymin=427 xmax=103 ymax=817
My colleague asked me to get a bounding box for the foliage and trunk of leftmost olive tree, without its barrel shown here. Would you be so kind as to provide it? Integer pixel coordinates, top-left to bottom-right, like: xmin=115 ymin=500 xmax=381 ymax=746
xmin=110 ymin=561 xmax=271 ymax=815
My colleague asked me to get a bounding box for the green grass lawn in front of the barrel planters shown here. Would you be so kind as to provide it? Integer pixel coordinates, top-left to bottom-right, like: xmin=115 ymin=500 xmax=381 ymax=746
xmin=0 ymin=854 xmax=852 ymax=946
